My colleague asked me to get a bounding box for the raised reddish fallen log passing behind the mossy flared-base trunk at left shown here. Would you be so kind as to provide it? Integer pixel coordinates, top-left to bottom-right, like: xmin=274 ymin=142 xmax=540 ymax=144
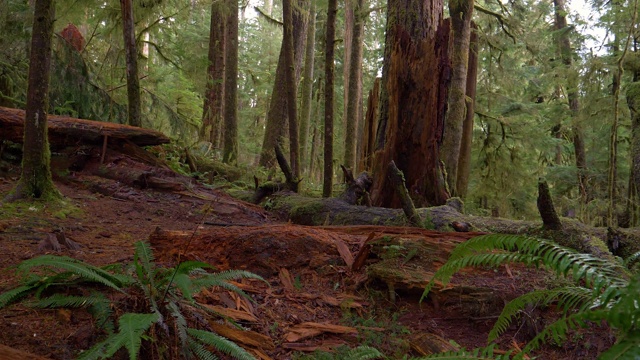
xmin=0 ymin=107 xmax=170 ymax=148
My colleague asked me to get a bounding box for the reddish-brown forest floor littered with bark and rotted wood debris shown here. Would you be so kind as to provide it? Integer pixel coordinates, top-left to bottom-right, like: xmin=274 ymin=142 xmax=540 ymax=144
xmin=0 ymin=145 xmax=613 ymax=359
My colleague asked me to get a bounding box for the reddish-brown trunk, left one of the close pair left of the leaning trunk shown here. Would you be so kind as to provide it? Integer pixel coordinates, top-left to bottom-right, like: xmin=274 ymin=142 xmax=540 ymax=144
xmin=200 ymin=1 xmax=226 ymax=148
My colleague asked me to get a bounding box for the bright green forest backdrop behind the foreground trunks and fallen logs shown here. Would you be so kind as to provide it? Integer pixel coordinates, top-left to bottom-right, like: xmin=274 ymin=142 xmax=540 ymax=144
xmin=0 ymin=0 xmax=640 ymax=226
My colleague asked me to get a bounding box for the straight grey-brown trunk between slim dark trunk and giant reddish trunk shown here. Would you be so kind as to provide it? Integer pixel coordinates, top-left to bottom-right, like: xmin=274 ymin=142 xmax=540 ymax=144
xmin=344 ymin=0 xmax=365 ymax=169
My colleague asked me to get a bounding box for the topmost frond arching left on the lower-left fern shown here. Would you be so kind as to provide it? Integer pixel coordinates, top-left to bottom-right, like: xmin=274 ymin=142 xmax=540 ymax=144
xmin=18 ymin=255 xmax=123 ymax=292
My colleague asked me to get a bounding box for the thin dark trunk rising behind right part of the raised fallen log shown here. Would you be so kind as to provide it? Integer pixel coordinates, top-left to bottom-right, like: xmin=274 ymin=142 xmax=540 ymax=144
xmin=120 ymin=0 xmax=142 ymax=126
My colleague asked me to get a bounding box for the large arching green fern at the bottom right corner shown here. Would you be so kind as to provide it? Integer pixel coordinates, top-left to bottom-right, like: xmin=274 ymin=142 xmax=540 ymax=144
xmin=423 ymin=234 xmax=640 ymax=359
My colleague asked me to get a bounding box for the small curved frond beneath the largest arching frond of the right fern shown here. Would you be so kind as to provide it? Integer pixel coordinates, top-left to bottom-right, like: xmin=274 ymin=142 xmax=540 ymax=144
xmin=487 ymin=287 xmax=593 ymax=342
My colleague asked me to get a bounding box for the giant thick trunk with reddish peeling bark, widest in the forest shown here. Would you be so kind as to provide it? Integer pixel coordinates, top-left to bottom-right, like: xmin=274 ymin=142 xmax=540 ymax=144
xmin=372 ymin=0 xmax=451 ymax=207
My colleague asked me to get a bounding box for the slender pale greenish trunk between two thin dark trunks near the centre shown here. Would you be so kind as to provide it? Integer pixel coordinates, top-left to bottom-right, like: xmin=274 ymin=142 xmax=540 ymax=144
xmin=300 ymin=1 xmax=316 ymax=176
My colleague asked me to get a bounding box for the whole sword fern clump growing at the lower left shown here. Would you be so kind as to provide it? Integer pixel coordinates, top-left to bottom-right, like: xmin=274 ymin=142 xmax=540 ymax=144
xmin=0 ymin=242 xmax=262 ymax=359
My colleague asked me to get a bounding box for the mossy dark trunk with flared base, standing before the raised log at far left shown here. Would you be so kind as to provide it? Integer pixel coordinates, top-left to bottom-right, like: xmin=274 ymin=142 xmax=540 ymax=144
xmin=8 ymin=0 xmax=60 ymax=200
